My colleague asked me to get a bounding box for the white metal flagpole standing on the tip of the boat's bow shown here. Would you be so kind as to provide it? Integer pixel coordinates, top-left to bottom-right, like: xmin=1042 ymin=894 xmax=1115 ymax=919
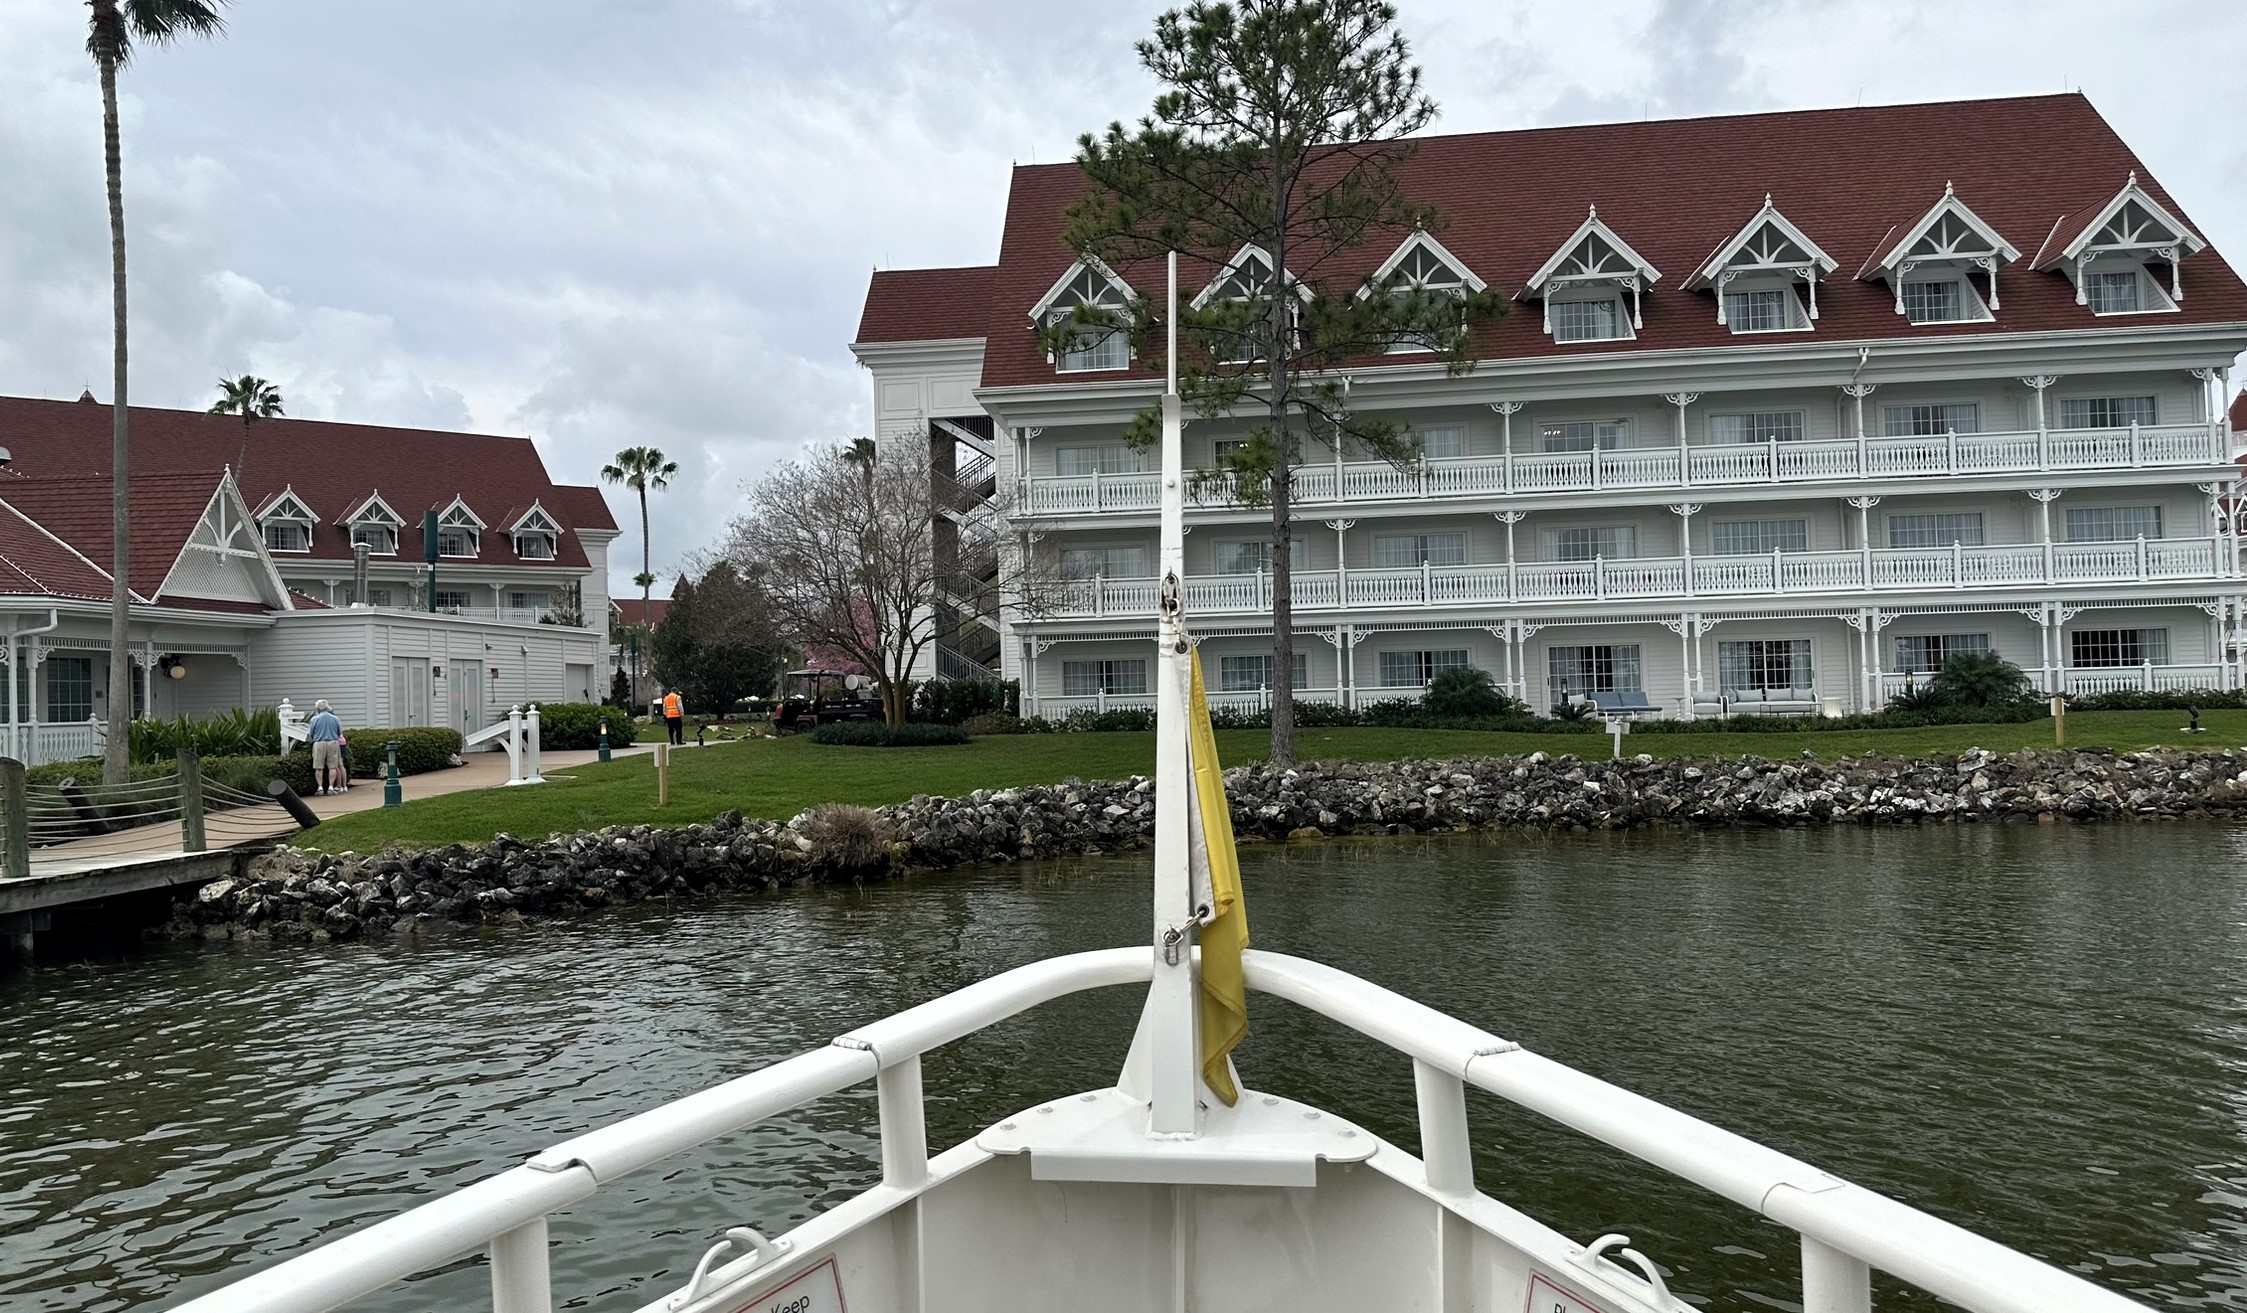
xmin=1148 ymin=252 xmax=1202 ymax=1138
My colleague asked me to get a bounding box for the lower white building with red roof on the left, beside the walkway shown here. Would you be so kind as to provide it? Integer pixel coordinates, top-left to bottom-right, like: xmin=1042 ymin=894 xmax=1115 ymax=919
xmin=0 ymin=398 xmax=618 ymax=764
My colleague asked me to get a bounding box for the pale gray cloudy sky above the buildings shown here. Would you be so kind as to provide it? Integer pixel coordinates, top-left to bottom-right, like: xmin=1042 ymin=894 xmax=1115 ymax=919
xmin=0 ymin=0 xmax=2247 ymax=587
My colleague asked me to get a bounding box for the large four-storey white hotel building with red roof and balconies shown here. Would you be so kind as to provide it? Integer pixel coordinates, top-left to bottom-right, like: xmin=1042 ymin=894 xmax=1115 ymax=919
xmin=852 ymin=94 xmax=2247 ymax=717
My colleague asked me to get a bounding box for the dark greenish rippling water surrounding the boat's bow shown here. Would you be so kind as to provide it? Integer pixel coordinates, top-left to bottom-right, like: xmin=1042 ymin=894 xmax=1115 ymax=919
xmin=0 ymin=825 xmax=2247 ymax=1313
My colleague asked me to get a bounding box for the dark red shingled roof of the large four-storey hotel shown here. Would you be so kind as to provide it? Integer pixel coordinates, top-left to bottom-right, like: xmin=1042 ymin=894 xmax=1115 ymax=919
xmin=948 ymin=92 xmax=2247 ymax=387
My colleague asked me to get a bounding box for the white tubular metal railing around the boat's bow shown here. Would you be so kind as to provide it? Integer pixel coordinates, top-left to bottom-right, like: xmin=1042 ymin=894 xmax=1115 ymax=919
xmin=178 ymin=947 xmax=2144 ymax=1313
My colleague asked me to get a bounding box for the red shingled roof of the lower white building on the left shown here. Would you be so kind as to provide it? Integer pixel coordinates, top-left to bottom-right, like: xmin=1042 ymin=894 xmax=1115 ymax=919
xmin=0 ymin=398 xmax=616 ymax=566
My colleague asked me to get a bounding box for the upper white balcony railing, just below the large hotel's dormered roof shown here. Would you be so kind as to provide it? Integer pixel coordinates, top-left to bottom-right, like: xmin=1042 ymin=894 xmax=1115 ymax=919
xmin=1022 ymin=423 xmax=2231 ymax=515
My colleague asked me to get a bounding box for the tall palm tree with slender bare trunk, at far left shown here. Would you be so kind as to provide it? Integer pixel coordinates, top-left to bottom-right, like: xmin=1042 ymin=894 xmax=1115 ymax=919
xmin=85 ymin=0 xmax=227 ymax=785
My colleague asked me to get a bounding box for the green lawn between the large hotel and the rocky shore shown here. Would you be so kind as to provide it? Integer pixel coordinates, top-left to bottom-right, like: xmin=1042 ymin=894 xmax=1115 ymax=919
xmin=301 ymin=710 xmax=2247 ymax=852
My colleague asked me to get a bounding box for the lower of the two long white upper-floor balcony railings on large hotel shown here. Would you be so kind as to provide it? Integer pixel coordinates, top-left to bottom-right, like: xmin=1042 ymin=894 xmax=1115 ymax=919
xmin=1038 ymin=537 xmax=2236 ymax=618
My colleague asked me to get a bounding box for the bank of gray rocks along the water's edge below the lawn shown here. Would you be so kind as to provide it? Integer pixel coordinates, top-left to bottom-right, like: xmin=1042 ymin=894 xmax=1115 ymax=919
xmin=164 ymin=749 xmax=2247 ymax=940
